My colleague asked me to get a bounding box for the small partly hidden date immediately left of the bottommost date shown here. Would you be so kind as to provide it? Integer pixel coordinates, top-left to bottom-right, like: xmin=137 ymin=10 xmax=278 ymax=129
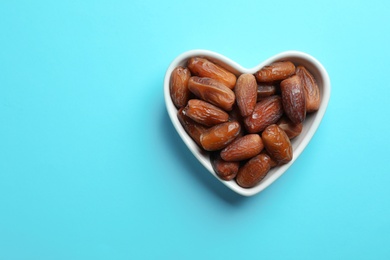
xmin=210 ymin=152 xmax=240 ymax=181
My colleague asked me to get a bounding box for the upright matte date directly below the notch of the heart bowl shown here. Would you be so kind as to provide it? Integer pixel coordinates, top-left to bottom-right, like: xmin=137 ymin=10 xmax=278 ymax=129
xmin=234 ymin=74 xmax=257 ymax=117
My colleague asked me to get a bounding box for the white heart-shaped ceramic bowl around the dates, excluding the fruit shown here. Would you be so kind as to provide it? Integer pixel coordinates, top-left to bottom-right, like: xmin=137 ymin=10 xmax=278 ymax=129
xmin=164 ymin=50 xmax=330 ymax=196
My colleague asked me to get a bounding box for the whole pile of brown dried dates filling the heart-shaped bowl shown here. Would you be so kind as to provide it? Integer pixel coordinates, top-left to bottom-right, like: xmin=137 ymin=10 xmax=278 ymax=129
xmin=169 ymin=57 xmax=320 ymax=188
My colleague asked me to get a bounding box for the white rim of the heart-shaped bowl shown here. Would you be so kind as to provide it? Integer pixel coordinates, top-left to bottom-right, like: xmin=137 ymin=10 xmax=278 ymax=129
xmin=164 ymin=49 xmax=331 ymax=196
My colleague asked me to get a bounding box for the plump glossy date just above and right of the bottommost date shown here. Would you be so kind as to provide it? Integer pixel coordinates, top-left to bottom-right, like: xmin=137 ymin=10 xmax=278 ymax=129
xmin=261 ymin=124 xmax=293 ymax=165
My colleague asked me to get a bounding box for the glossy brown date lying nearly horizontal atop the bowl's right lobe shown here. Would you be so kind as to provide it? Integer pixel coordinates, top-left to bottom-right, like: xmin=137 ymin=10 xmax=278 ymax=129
xmin=255 ymin=61 xmax=295 ymax=82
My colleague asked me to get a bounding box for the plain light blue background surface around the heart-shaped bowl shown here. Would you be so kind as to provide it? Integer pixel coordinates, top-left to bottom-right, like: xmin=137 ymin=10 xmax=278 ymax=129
xmin=0 ymin=0 xmax=390 ymax=260
